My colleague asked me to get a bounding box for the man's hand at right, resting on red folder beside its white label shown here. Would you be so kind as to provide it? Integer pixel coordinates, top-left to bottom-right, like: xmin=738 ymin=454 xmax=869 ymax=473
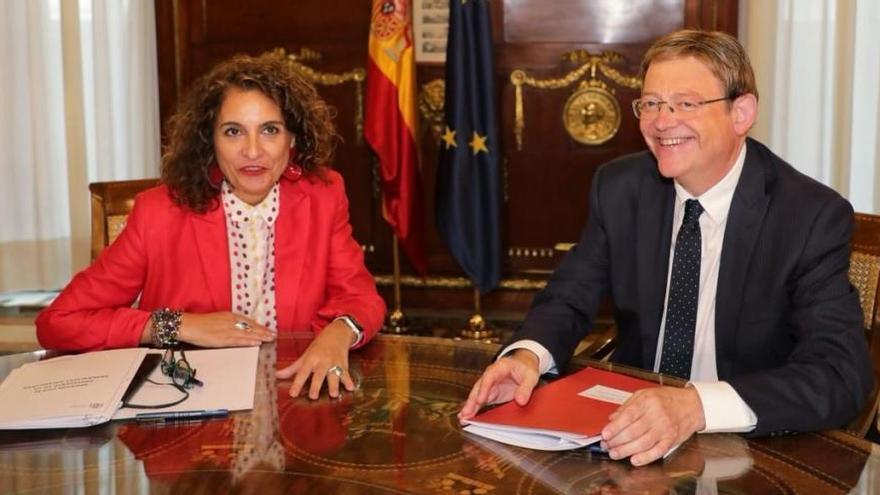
xmin=602 ymin=387 xmax=706 ymax=466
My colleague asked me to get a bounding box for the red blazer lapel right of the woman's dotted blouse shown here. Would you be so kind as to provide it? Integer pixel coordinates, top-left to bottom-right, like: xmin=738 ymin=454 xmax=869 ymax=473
xmin=275 ymin=179 xmax=312 ymax=330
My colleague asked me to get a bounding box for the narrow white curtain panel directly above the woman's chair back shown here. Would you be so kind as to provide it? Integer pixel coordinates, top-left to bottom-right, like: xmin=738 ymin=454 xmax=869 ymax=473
xmin=79 ymin=0 xmax=160 ymax=181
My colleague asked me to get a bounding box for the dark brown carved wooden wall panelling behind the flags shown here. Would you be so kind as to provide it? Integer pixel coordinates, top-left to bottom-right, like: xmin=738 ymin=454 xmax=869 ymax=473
xmin=155 ymin=0 xmax=737 ymax=313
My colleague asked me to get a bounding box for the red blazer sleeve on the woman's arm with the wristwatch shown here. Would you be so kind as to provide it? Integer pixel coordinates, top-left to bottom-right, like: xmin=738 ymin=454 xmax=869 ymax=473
xmin=313 ymin=178 xmax=385 ymax=345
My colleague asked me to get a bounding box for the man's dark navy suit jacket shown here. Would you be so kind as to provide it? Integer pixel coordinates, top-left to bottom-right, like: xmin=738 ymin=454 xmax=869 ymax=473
xmin=513 ymin=139 xmax=873 ymax=434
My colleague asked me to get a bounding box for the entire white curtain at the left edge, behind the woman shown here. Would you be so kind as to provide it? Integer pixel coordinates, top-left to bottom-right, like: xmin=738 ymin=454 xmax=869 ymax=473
xmin=0 ymin=0 xmax=160 ymax=291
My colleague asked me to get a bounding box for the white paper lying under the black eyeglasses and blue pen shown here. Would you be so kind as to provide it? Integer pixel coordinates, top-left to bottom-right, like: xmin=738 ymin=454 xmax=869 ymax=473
xmin=113 ymin=347 xmax=260 ymax=419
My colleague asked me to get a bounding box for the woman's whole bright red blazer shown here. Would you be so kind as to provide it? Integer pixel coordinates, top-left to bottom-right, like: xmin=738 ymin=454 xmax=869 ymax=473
xmin=36 ymin=171 xmax=385 ymax=350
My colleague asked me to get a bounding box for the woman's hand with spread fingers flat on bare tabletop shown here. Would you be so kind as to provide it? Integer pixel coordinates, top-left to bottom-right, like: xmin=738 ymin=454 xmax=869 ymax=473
xmin=275 ymin=320 xmax=354 ymax=400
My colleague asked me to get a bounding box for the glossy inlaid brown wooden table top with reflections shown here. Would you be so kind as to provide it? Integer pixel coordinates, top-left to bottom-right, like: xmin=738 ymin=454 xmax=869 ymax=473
xmin=0 ymin=335 xmax=880 ymax=495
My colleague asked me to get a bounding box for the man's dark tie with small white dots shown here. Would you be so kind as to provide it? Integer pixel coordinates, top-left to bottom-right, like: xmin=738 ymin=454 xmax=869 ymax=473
xmin=660 ymin=199 xmax=703 ymax=378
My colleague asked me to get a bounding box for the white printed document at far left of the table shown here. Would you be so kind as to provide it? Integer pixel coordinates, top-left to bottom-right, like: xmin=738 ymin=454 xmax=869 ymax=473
xmin=0 ymin=348 xmax=147 ymax=429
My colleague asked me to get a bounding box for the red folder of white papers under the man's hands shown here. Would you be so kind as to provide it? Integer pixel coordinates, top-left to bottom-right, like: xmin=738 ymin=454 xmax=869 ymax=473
xmin=464 ymin=368 xmax=659 ymax=450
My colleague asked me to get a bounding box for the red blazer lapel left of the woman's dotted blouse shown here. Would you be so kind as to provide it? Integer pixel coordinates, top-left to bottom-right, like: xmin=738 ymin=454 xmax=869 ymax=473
xmin=192 ymin=206 xmax=232 ymax=311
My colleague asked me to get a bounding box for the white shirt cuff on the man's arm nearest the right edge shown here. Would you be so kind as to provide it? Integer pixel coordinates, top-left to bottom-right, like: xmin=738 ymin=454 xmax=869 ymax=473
xmin=688 ymin=382 xmax=758 ymax=433
